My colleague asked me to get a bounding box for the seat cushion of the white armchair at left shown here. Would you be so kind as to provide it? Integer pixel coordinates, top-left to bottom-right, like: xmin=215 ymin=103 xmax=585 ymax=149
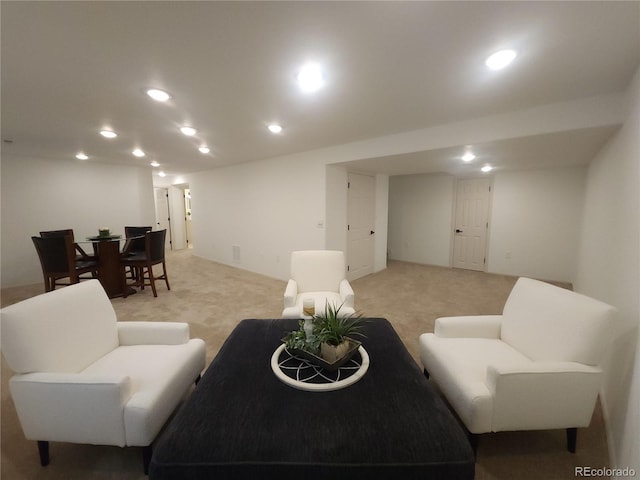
xmin=83 ymin=339 xmax=205 ymax=446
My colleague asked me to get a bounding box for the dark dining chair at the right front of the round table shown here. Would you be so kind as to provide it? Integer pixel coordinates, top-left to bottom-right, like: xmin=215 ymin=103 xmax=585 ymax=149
xmin=121 ymin=230 xmax=171 ymax=298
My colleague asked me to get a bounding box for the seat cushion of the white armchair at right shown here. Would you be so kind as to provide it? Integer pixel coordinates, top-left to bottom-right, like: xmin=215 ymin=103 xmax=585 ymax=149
xmin=420 ymin=333 xmax=531 ymax=433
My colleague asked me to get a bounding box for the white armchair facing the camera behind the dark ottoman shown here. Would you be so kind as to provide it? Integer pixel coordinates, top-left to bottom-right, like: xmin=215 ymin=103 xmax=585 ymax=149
xmin=282 ymin=250 xmax=355 ymax=318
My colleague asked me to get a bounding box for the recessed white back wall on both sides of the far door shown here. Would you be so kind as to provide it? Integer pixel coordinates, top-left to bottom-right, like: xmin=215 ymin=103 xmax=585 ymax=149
xmin=389 ymin=167 xmax=586 ymax=281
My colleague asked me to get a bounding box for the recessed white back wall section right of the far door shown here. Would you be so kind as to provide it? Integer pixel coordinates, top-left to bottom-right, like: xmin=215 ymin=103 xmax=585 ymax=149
xmin=487 ymin=167 xmax=586 ymax=282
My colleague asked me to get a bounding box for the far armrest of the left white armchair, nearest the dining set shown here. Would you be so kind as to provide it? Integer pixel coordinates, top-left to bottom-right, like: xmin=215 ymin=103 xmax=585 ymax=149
xmin=117 ymin=322 xmax=189 ymax=345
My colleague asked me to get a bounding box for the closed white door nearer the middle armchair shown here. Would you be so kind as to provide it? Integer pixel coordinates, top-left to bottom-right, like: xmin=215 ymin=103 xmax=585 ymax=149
xmin=347 ymin=173 xmax=376 ymax=280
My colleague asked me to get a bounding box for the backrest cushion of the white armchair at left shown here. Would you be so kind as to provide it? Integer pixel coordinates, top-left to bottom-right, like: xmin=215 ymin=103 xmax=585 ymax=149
xmin=0 ymin=280 xmax=118 ymax=373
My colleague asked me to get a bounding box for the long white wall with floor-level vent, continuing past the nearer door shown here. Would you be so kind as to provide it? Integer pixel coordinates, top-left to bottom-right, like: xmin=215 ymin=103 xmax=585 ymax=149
xmin=188 ymin=152 xmax=388 ymax=280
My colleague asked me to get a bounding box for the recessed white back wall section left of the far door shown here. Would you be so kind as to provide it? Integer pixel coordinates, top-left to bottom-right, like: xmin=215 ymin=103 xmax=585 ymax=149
xmin=388 ymin=174 xmax=455 ymax=266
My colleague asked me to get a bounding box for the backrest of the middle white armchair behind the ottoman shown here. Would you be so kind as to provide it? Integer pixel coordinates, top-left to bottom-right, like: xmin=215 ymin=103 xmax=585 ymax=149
xmin=291 ymin=250 xmax=346 ymax=293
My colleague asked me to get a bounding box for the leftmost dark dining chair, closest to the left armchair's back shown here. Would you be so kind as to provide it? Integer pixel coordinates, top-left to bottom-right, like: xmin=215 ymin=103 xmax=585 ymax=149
xmin=31 ymin=235 xmax=98 ymax=292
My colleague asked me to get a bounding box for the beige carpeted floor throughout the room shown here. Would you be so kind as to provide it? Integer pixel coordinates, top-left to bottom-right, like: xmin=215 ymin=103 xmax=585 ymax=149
xmin=0 ymin=250 xmax=608 ymax=480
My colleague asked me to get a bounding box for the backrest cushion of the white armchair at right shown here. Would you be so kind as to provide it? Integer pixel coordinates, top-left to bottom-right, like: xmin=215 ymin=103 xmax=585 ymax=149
xmin=501 ymin=278 xmax=615 ymax=365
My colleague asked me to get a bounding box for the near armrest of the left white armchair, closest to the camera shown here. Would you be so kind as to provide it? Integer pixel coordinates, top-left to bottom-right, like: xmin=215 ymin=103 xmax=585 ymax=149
xmin=9 ymin=373 xmax=132 ymax=446
